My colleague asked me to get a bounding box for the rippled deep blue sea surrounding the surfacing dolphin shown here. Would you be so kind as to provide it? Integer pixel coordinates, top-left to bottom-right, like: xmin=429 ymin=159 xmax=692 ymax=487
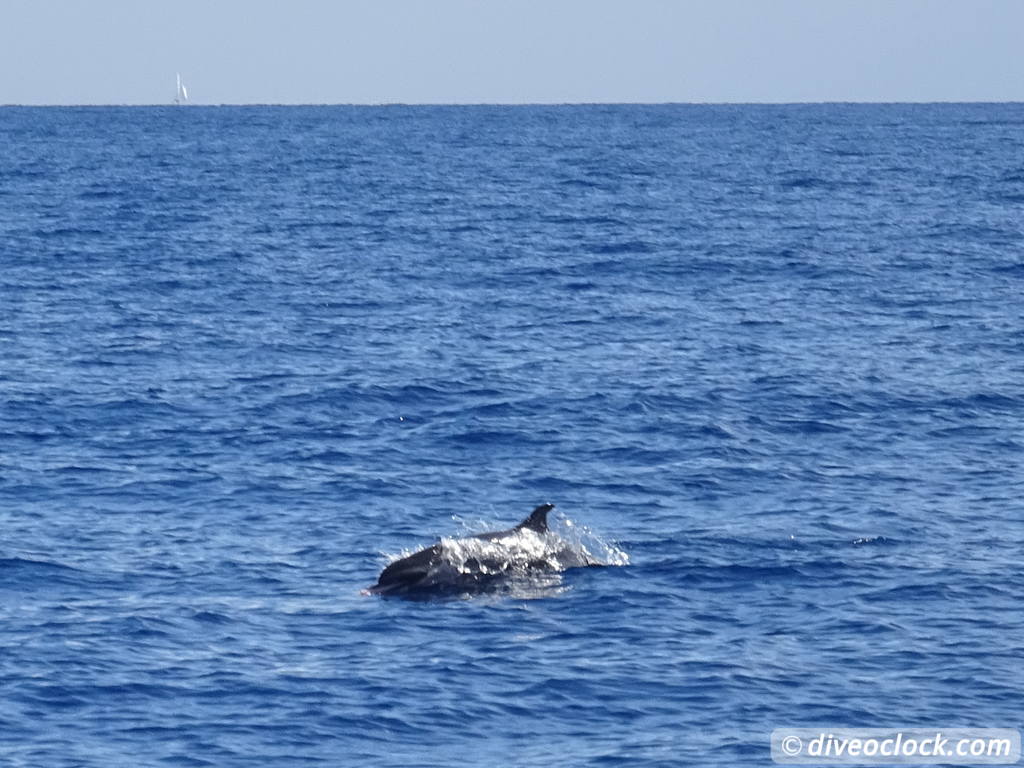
xmin=0 ymin=104 xmax=1024 ymax=768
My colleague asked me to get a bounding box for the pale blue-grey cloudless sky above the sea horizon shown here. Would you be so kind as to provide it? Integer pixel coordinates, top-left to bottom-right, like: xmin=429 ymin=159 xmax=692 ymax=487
xmin=0 ymin=0 xmax=1024 ymax=104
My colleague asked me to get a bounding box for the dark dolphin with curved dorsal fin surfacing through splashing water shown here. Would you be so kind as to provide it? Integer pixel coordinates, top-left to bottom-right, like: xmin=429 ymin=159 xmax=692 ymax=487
xmin=367 ymin=504 xmax=600 ymax=595
